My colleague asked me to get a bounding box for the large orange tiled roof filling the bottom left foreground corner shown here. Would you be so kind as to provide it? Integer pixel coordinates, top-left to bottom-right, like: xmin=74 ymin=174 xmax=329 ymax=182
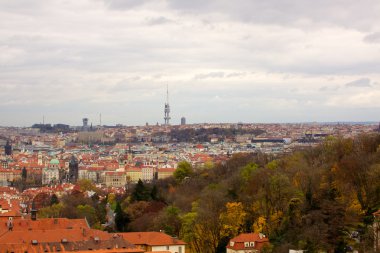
xmin=0 ymin=218 xmax=143 ymax=253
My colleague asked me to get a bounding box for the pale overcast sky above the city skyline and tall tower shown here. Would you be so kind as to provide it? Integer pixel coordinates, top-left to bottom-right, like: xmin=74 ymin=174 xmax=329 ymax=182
xmin=0 ymin=0 xmax=380 ymax=126
